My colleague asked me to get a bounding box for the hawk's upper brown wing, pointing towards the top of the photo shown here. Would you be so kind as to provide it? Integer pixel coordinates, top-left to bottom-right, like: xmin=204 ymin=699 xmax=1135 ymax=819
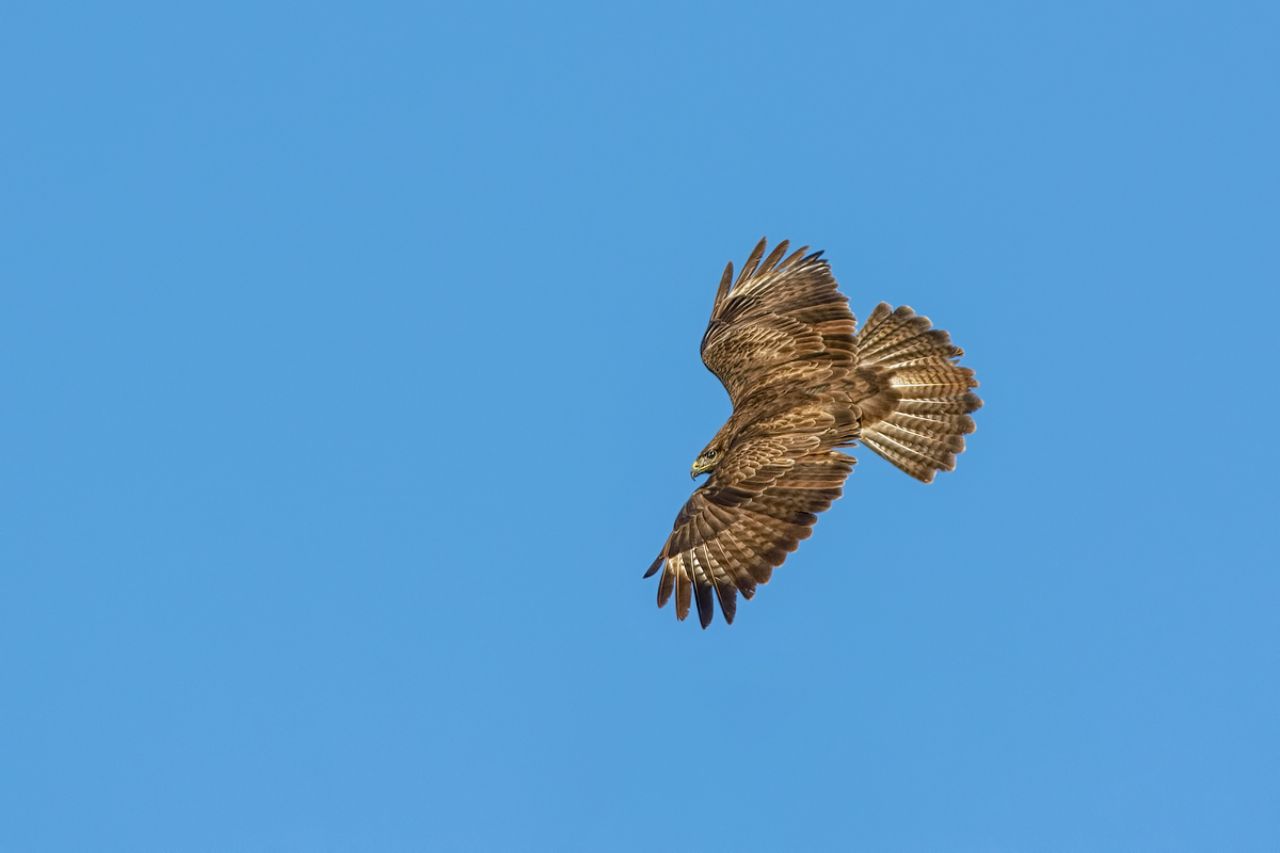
xmin=701 ymin=240 xmax=854 ymax=407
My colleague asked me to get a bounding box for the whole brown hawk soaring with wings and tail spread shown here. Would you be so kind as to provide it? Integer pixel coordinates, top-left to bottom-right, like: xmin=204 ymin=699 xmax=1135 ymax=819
xmin=645 ymin=240 xmax=982 ymax=628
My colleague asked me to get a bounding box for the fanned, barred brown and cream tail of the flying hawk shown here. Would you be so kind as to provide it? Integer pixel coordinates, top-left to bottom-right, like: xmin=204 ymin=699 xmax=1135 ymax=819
xmin=854 ymin=302 xmax=982 ymax=483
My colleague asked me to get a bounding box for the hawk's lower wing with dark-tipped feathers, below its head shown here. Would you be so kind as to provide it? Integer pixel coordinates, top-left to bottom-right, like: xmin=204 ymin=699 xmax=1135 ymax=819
xmin=645 ymin=434 xmax=854 ymax=628
